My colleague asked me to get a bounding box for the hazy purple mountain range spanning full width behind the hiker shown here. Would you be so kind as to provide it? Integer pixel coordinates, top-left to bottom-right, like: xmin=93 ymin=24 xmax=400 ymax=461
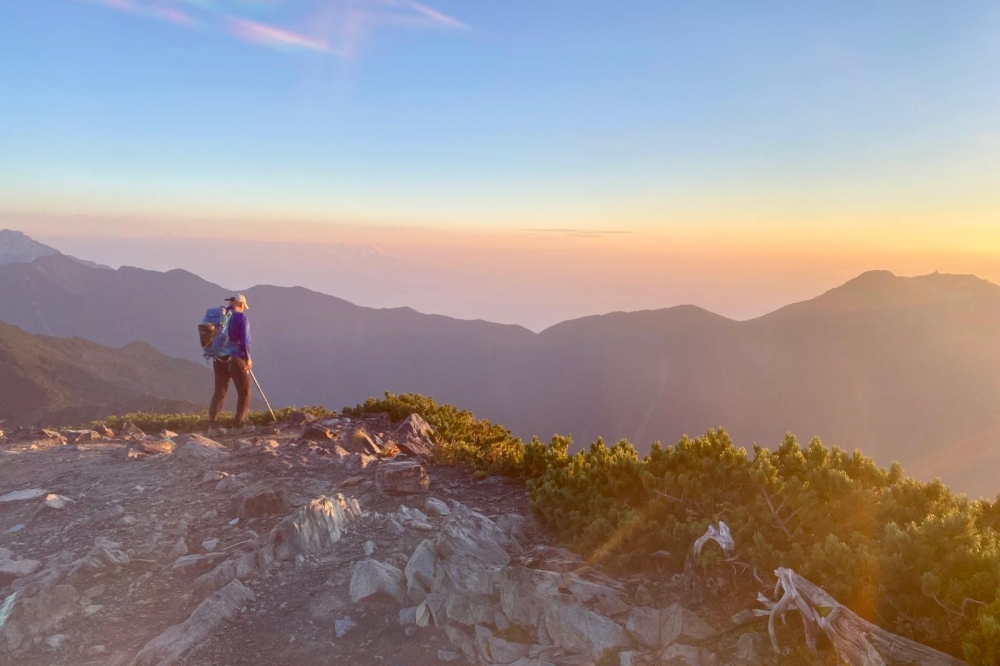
xmin=0 ymin=231 xmax=1000 ymax=496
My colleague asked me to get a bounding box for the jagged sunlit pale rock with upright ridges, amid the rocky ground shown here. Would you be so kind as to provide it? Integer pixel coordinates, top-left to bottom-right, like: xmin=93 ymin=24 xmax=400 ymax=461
xmin=271 ymin=493 xmax=364 ymax=560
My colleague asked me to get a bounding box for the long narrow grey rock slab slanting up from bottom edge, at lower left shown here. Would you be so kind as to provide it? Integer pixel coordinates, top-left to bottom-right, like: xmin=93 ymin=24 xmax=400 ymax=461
xmin=129 ymin=580 xmax=254 ymax=666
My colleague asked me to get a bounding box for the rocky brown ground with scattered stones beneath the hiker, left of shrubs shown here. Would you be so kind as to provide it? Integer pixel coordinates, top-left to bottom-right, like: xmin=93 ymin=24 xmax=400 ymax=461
xmin=0 ymin=415 xmax=828 ymax=666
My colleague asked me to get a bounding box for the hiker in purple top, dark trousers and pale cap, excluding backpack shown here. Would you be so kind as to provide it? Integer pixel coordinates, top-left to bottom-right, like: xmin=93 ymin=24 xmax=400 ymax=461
xmin=208 ymin=294 xmax=254 ymax=435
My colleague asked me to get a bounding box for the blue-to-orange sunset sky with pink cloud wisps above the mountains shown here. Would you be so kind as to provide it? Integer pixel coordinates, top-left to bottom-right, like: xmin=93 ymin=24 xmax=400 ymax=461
xmin=0 ymin=0 xmax=1000 ymax=326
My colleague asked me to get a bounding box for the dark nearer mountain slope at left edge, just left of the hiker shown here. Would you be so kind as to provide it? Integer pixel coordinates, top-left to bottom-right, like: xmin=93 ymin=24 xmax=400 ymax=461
xmin=0 ymin=323 xmax=212 ymax=427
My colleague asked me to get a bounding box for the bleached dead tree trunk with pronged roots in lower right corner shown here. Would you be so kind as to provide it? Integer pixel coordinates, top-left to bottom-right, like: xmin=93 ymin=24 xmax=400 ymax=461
xmin=756 ymin=567 xmax=966 ymax=666
